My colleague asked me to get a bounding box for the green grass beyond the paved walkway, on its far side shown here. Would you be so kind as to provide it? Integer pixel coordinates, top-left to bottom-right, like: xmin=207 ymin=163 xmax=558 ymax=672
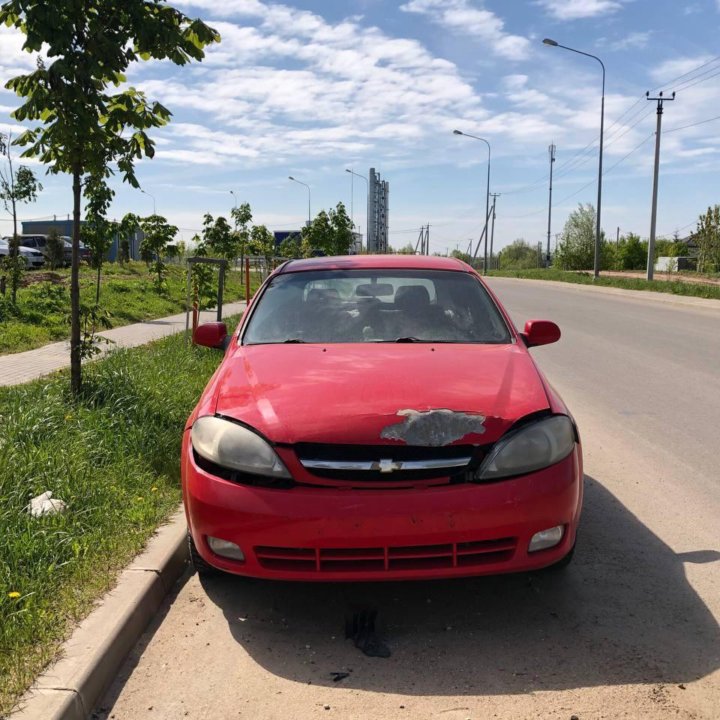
xmin=0 ymin=262 xmax=259 ymax=354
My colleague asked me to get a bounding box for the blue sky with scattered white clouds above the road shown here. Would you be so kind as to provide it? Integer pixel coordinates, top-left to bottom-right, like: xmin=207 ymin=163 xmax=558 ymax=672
xmin=0 ymin=0 xmax=720 ymax=254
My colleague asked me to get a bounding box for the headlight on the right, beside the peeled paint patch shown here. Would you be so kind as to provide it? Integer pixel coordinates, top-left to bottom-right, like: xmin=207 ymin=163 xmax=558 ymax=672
xmin=475 ymin=415 xmax=575 ymax=480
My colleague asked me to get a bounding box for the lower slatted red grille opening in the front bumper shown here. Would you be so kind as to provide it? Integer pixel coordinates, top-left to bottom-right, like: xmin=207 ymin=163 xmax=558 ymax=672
xmin=255 ymin=537 xmax=517 ymax=573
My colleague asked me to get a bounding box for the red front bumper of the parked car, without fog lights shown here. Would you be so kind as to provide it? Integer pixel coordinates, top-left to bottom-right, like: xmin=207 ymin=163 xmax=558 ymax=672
xmin=182 ymin=433 xmax=582 ymax=581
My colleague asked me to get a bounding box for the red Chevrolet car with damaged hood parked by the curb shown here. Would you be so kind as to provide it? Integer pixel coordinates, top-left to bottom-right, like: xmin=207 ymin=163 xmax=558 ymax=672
xmin=182 ymin=255 xmax=583 ymax=581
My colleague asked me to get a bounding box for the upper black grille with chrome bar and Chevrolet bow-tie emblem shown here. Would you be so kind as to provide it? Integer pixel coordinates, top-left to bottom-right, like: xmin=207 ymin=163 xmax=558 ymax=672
xmin=295 ymin=443 xmax=484 ymax=484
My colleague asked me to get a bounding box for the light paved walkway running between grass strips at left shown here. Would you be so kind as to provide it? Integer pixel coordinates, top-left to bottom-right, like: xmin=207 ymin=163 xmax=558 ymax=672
xmin=0 ymin=302 xmax=245 ymax=386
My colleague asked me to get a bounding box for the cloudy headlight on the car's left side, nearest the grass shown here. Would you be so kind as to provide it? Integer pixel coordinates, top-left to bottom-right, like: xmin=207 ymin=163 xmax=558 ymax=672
xmin=190 ymin=416 xmax=290 ymax=478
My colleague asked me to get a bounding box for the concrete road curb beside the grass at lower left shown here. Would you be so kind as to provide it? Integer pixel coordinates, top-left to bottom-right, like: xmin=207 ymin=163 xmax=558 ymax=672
xmin=10 ymin=510 xmax=188 ymax=720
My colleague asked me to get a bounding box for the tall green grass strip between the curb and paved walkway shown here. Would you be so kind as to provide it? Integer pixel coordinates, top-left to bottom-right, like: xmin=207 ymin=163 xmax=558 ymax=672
xmin=0 ymin=321 xmax=240 ymax=717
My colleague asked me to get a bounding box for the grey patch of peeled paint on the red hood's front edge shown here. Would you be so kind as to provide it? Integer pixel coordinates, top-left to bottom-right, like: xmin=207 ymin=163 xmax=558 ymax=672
xmin=380 ymin=409 xmax=485 ymax=447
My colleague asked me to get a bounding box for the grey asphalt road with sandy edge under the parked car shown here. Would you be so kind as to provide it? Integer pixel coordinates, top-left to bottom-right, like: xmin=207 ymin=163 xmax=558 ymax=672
xmin=96 ymin=279 xmax=720 ymax=720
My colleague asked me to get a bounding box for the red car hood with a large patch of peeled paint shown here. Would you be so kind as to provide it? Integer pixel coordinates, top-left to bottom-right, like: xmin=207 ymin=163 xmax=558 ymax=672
xmin=215 ymin=343 xmax=549 ymax=446
